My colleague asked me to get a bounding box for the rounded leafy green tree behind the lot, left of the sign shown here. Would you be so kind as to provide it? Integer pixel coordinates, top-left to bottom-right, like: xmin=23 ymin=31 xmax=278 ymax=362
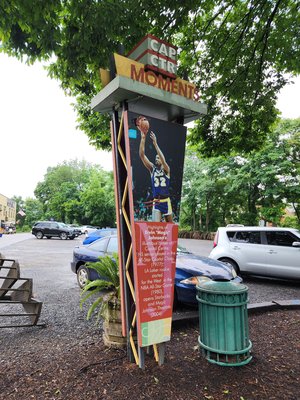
xmin=34 ymin=160 xmax=115 ymax=225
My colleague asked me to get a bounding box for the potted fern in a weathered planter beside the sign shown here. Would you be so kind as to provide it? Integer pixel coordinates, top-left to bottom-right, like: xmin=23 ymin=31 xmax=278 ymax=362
xmin=80 ymin=254 xmax=126 ymax=347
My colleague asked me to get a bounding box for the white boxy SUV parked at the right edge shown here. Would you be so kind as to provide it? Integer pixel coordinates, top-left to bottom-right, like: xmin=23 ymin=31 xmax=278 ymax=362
xmin=209 ymin=226 xmax=300 ymax=280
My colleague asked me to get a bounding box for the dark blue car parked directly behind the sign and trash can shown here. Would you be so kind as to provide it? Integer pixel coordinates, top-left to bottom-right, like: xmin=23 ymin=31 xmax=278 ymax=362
xmin=71 ymin=235 xmax=242 ymax=305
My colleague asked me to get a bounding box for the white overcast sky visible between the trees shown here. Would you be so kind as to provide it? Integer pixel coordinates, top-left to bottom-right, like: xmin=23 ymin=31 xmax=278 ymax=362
xmin=0 ymin=54 xmax=300 ymax=199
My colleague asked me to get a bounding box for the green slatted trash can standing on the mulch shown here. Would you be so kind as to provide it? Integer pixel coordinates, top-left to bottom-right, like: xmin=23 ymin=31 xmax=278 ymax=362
xmin=197 ymin=281 xmax=252 ymax=367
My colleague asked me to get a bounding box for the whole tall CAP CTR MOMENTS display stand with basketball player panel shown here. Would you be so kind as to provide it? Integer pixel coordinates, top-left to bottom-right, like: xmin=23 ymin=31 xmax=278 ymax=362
xmin=92 ymin=35 xmax=206 ymax=367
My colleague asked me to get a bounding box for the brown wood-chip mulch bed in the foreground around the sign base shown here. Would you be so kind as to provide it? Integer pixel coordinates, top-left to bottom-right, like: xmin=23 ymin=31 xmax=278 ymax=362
xmin=0 ymin=310 xmax=300 ymax=400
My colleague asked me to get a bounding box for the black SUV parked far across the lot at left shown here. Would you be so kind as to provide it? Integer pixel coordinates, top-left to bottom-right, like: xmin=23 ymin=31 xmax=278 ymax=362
xmin=31 ymin=221 xmax=75 ymax=240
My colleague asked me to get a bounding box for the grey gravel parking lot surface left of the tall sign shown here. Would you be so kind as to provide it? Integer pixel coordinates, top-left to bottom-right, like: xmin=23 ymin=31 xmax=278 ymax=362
xmin=0 ymin=238 xmax=99 ymax=340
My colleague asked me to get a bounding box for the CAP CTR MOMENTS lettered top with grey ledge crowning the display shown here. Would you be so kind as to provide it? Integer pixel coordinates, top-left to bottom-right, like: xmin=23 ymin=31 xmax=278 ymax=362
xmin=91 ymin=34 xmax=207 ymax=124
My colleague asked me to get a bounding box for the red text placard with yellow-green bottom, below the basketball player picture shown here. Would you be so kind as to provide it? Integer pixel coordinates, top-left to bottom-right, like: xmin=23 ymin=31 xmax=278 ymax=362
xmin=134 ymin=222 xmax=178 ymax=347
